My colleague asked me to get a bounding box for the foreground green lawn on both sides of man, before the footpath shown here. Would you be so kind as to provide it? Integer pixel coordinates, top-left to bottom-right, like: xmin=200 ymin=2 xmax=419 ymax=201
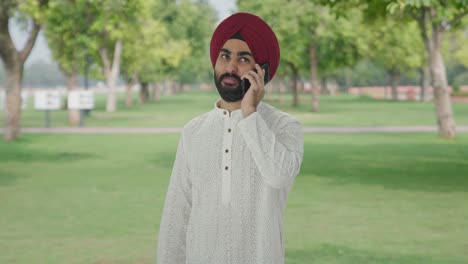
xmin=0 ymin=133 xmax=468 ymax=264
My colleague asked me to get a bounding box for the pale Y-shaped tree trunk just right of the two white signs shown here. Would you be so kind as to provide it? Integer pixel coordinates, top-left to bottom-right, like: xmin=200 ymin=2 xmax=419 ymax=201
xmin=99 ymin=39 xmax=122 ymax=112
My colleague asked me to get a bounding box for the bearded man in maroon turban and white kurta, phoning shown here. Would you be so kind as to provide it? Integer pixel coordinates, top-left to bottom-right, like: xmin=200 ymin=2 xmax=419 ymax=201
xmin=158 ymin=13 xmax=303 ymax=264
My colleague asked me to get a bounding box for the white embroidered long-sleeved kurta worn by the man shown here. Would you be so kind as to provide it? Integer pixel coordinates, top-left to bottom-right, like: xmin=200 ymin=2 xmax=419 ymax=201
xmin=157 ymin=102 xmax=304 ymax=264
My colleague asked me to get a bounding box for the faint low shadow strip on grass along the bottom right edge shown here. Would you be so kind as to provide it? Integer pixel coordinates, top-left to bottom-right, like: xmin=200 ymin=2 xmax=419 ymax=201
xmin=286 ymin=244 xmax=462 ymax=264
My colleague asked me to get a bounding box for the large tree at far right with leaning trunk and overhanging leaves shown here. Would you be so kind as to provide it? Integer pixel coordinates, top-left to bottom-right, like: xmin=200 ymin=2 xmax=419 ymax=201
xmin=330 ymin=0 xmax=468 ymax=139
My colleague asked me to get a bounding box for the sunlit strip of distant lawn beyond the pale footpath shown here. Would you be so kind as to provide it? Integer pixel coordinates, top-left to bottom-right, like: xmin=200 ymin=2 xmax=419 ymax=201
xmin=10 ymin=90 xmax=468 ymax=127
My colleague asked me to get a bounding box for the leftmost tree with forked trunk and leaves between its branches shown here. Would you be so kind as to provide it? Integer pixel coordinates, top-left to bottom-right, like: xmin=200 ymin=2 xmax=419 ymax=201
xmin=0 ymin=0 xmax=48 ymax=141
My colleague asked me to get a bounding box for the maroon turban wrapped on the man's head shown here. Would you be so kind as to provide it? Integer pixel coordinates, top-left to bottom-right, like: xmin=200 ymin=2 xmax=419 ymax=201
xmin=210 ymin=13 xmax=280 ymax=80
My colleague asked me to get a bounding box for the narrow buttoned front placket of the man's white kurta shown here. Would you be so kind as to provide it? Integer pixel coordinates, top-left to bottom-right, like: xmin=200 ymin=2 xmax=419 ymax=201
xmin=221 ymin=111 xmax=233 ymax=205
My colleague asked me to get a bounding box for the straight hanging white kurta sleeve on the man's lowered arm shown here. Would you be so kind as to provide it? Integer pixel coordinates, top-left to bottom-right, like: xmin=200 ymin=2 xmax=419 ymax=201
xmin=157 ymin=135 xmax=192 ymax=264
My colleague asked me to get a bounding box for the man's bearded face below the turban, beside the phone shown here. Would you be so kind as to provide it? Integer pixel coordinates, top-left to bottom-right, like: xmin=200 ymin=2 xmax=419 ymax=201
xmin=214 ymin=39 xmax=255 ymax=102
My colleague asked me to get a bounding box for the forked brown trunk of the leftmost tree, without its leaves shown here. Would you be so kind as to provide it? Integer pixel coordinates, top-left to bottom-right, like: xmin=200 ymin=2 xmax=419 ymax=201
xmin=0 ymin=12 xmax=41 ymax=141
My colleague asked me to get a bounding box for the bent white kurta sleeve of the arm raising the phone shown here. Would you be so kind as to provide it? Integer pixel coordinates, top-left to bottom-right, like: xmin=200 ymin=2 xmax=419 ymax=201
xmin=238 ymin=112 xmax=304 ymax=188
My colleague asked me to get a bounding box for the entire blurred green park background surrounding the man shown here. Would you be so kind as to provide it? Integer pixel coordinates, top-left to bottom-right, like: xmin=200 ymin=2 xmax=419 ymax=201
xmin=0 ymin=0 xmax=468 ymax=264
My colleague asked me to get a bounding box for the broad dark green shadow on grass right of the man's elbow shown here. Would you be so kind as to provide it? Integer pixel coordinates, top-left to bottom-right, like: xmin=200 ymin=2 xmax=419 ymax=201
xmin=299 ymin=140 xmax=468 ymax=192
